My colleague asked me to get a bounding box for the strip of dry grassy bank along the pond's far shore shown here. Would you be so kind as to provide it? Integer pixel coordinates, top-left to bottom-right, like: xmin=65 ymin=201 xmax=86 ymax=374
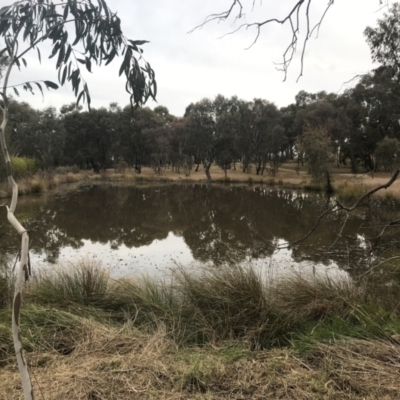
xmin=0 ymin=163 xmax=400 ymax=202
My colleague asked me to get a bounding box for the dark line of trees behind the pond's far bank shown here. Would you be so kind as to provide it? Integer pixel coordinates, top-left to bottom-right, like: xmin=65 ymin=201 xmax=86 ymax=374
xmin=2 ymin=66 xmax=400 ymax=182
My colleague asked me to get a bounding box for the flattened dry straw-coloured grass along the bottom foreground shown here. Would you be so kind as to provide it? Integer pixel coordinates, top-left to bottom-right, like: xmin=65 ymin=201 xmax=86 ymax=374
xmin=0 ymin=320 xmax=400 ymax=400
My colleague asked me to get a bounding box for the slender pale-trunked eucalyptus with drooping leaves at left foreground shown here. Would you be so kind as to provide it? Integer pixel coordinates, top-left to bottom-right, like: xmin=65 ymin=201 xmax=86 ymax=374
xmin=0 ymin=0 xmax=156 ymax=399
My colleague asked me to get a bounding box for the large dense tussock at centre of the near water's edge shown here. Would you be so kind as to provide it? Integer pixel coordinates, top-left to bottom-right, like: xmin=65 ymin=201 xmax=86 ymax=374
xmin=177 ymin=265 xmax=282 ymax=347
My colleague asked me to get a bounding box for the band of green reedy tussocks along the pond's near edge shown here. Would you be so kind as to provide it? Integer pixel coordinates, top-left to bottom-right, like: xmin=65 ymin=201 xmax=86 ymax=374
xmin=20 ymin=260 xmax=400 ymax=349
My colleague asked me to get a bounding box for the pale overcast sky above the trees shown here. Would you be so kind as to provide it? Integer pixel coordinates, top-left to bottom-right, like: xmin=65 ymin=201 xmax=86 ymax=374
xmin=6 ymin=0 xmax=383 ymax=116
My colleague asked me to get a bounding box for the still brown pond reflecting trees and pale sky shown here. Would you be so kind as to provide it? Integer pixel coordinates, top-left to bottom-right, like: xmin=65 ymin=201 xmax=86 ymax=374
xmin=0 ymin=184 xmax=400 ymax=276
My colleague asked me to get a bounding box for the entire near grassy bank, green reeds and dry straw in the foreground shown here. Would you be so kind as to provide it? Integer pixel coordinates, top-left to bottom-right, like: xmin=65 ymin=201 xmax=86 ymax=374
xmin=0 ymin=262 xmax=400 ymax=400
